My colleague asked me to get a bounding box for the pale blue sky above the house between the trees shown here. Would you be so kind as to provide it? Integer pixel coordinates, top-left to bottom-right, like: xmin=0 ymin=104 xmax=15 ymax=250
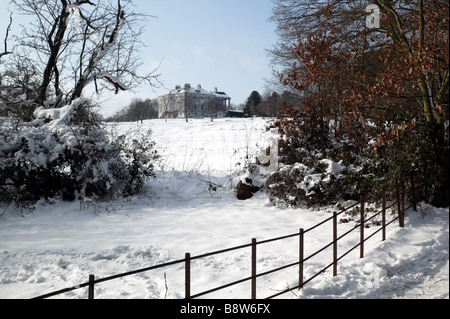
xmin=0 ymin=0 xmax=277 ymax=115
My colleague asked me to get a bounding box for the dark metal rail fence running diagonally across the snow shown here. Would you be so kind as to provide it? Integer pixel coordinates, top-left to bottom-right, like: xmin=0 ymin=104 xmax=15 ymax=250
xmin=33 ymin=178 xmax=423 ymax=299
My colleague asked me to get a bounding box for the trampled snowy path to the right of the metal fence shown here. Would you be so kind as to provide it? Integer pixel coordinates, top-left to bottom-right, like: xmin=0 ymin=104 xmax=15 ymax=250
xmin=301 ymin=205 xmax=449 ymax=299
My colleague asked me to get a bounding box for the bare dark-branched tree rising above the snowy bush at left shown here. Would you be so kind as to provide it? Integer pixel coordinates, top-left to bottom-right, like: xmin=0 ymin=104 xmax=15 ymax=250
xmin=11 ymin=0 xmax=159 ymax=107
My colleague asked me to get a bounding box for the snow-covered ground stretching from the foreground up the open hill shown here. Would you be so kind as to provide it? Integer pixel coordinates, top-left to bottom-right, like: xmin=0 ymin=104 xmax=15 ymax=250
xmin=0 ymin=119 xmax=449 ymax=299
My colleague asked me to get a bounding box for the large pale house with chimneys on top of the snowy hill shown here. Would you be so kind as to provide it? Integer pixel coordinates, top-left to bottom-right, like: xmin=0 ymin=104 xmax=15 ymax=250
xmin=158 ymin=83 xmax=231 ymax=118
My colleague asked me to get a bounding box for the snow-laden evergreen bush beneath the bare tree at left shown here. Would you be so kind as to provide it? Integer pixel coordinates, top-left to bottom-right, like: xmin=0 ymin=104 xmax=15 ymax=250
xmin=0 ymin=99 xmax=157 ymax=202
